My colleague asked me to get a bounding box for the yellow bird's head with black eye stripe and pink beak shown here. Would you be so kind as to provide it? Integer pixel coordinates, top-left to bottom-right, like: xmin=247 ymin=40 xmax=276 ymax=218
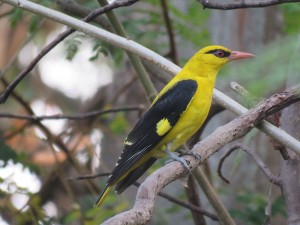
xmin=193 ymin=45 xmax=255 ymax=70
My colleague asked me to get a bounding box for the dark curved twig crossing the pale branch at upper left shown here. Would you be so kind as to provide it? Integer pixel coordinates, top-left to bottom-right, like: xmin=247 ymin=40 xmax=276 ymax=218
xmin=0 ymin=0 xmax=139 ymax=104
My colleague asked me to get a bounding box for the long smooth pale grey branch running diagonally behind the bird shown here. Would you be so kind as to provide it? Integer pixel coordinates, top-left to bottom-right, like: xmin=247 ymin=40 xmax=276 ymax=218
xmin=0 ymin=0 xmax=300 ymax=154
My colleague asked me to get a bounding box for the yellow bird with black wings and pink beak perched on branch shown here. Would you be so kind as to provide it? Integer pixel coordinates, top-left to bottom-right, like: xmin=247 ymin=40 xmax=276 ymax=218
xmin=95 ymin=46 xmax=254 ymax=206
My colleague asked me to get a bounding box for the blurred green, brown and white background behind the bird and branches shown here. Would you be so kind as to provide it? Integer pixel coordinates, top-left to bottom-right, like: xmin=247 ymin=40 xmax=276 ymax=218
xmin=0 ymin=0 xmax=300 ymax=225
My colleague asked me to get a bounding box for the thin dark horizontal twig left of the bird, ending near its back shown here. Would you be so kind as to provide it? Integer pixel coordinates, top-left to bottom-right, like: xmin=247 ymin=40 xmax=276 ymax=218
xmin=0 ymin=106 xmax=144 ymax=121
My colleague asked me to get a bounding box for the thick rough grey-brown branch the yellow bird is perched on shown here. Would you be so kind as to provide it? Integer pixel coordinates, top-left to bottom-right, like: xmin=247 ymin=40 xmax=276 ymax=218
xmin=103 ymin=87 xmax=299 ymax=225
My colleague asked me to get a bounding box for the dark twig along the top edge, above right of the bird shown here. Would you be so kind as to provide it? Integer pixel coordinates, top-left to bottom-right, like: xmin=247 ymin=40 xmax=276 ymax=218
xmin=198 ymin=0 xmax=299 ymax=10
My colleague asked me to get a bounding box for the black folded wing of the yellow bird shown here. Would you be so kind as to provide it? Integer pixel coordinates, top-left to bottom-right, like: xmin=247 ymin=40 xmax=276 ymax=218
xmin=107 ymin=80 xmax=198 ymax=185
